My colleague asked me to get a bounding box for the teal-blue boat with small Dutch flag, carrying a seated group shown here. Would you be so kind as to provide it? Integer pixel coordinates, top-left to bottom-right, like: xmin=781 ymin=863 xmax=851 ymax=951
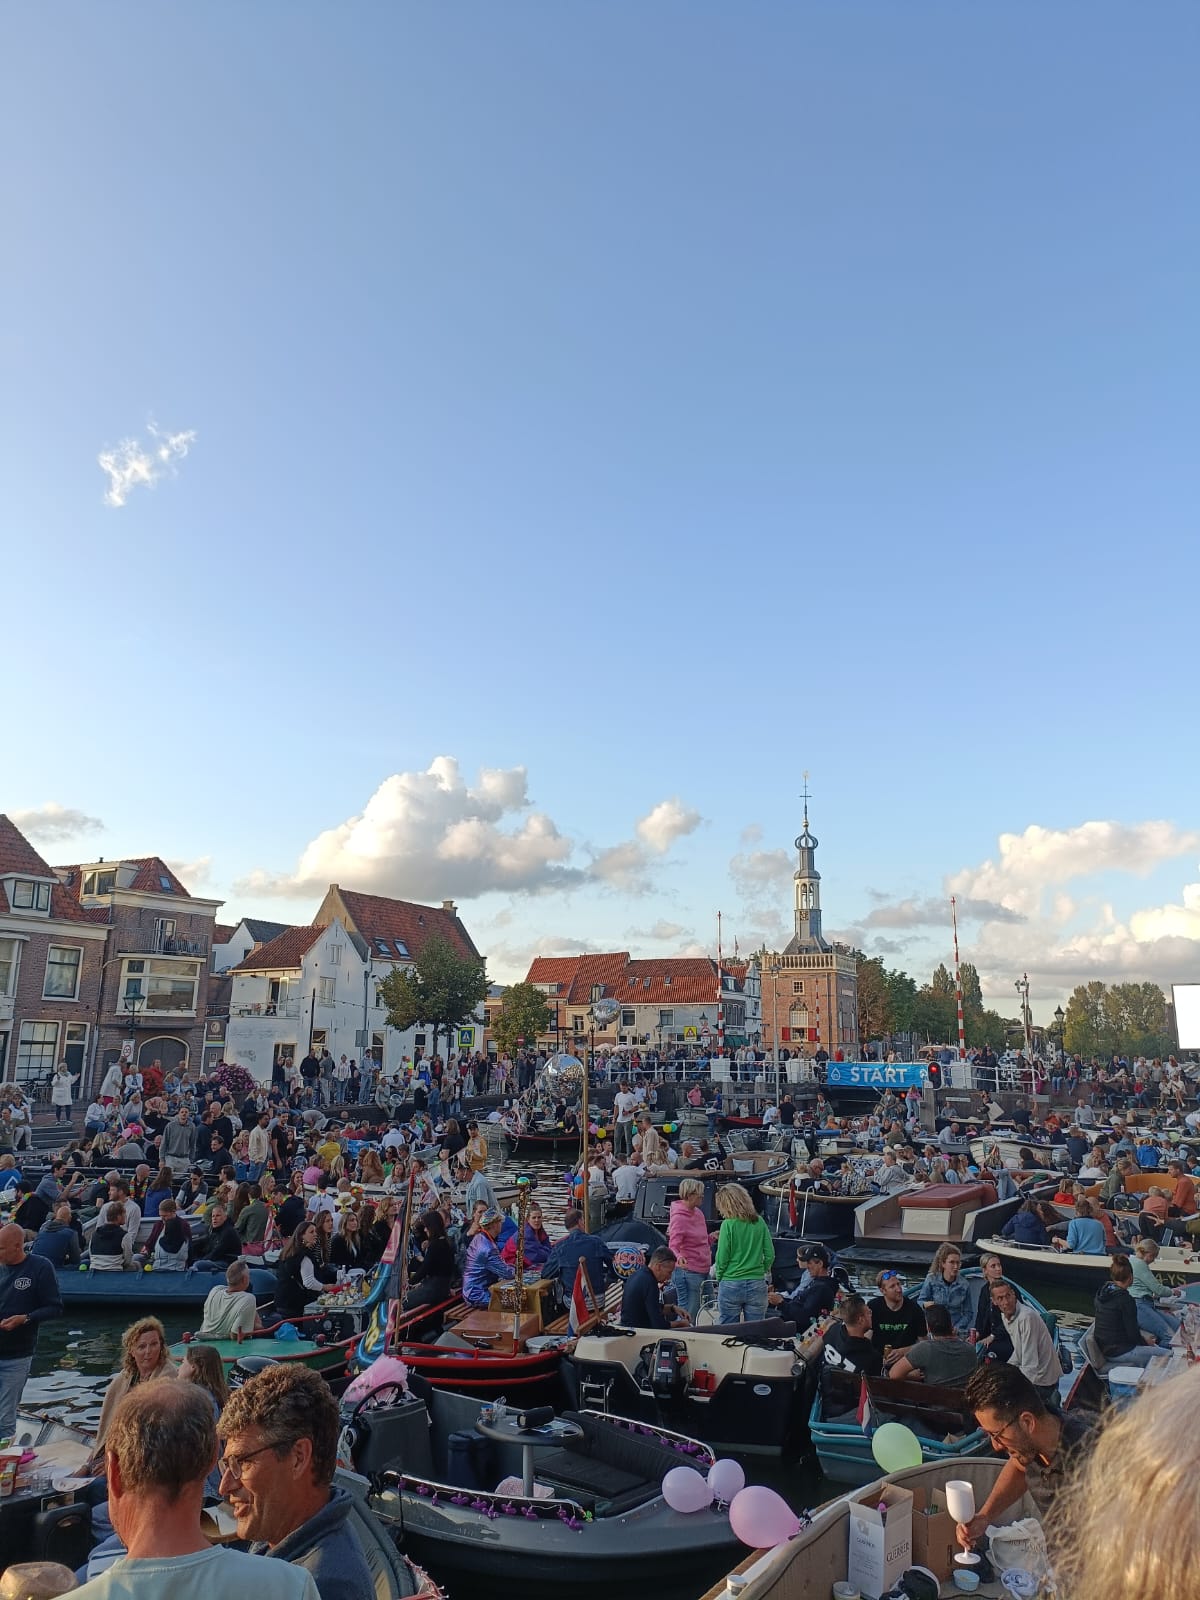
xmin=808 ymin=1269 xmax=1059 ymax=1483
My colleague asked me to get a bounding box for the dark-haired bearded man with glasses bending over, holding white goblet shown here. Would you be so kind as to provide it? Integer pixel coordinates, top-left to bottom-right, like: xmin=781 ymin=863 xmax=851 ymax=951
xmin=958 ymin=1363 xmax=1091 ymax=1550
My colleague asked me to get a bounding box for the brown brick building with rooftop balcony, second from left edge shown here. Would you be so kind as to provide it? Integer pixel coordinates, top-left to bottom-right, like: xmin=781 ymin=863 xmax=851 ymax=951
xmin=54 ymin=856 xmax=221 ymax=1086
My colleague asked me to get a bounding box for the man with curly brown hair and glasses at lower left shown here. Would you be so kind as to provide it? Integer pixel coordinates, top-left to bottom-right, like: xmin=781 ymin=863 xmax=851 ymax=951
xmin=218 ymin=1365 xmax=374 ymax=1600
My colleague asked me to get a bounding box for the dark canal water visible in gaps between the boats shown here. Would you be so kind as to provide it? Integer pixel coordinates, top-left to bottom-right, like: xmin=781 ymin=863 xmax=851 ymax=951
xmin=34 ymin=1146 xmax=1091 ymax=1600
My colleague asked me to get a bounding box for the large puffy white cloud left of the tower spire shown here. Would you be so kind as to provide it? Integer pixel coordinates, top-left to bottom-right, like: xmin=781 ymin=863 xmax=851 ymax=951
xmin=235 ymin=755 xmax=699 ymax=899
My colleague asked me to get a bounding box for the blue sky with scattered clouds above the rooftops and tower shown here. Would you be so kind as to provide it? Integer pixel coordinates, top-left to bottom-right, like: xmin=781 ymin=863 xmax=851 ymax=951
xmin=0 ymin=0 xmax=1200 ymax=1019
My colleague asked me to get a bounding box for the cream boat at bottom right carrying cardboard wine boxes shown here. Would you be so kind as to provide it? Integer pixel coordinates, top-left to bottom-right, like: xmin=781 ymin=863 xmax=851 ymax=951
xmin=701 ymin=1454 xmax=1040 ymax=1600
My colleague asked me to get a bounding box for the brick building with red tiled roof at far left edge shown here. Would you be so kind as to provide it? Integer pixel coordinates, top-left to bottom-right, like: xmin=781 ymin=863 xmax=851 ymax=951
xmin=0 ymin=816 xmax=109 ymax=1098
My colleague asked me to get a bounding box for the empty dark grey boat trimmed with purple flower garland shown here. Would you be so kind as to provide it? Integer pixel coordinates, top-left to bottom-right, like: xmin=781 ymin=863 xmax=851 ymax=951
xmin=341 ymin=1374 xmax=738 ymax=1597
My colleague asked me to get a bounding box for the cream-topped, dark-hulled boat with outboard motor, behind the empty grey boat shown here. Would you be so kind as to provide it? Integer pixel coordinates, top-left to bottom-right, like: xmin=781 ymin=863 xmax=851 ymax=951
xmin=562 ymin=1317 xmax=821 ymax=1456
